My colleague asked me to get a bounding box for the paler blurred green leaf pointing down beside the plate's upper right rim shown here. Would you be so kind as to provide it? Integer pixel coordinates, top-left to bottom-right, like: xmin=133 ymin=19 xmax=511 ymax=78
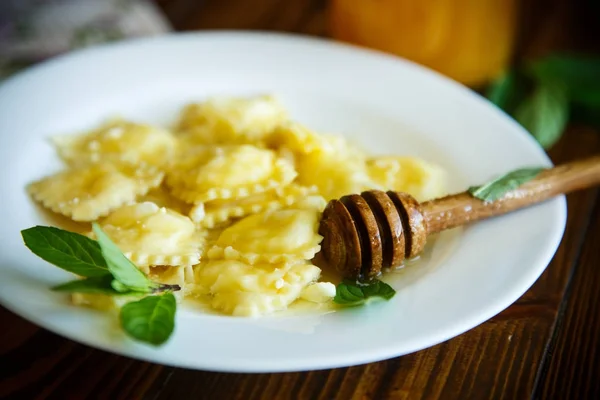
xmin=515 ymin=82 xmax=569 ymax=149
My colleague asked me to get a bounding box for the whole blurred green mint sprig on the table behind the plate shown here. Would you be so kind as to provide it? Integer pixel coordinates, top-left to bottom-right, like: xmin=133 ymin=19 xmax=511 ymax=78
xmin=486 ymin=54 xmax=600 ymax=149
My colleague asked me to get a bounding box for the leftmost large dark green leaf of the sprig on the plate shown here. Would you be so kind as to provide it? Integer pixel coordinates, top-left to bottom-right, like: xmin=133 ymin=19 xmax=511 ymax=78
xmin=21 ymin=226 xmax=110 ymax=278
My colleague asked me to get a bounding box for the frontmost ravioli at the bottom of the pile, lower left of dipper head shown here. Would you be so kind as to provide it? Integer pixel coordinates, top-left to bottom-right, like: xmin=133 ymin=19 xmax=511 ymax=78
xmin=195 ymin=260 xmax=321 ymax=317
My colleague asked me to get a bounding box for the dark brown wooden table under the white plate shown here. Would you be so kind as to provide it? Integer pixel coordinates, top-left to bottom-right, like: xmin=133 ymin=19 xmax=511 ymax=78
xmin=0 ymin=0 xmax=600 ymax=400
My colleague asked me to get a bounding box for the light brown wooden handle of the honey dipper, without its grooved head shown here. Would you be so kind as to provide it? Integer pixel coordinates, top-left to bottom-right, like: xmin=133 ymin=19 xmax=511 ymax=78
xmin=421 ymin=156 xmax=600 ymax=234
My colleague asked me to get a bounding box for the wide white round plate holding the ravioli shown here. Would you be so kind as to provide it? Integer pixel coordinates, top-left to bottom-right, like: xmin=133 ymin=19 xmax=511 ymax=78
xmin=0 ymin=33 xmax=566 ymax=372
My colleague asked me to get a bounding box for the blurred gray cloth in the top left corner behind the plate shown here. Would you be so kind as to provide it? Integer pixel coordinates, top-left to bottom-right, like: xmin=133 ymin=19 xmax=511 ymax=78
xmin=0 ymin=0 xmax=171 ymax=78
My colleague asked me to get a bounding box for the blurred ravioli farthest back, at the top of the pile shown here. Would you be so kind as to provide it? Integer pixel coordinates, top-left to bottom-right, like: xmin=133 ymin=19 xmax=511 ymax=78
xmin=177 ymin=95 xmax=288 ymax=144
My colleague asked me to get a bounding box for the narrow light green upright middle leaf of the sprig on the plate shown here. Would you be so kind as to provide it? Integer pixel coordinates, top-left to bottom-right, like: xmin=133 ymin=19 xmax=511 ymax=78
xmin=92 ymin=223 xmax=157 ymax=293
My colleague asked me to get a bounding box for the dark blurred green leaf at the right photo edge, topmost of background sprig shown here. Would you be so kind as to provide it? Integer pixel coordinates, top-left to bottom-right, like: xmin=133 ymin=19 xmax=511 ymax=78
xmin=527 ymin=54 xmax=600 ymax=107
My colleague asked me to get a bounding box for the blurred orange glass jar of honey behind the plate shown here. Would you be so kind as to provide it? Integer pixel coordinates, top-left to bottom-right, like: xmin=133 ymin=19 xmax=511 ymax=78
xmin=329 ymin=0 xmax=517 ymax=87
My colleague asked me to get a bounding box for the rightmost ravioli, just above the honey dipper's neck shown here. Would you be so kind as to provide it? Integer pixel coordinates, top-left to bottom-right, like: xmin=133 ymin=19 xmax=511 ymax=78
xmin=367 ymin=156 xmax=446 ymax=202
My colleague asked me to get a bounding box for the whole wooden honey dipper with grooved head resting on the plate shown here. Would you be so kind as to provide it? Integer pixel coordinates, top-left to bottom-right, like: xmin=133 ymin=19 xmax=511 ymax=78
xmin=319 ymin=156 xmax=600 ymax=279
